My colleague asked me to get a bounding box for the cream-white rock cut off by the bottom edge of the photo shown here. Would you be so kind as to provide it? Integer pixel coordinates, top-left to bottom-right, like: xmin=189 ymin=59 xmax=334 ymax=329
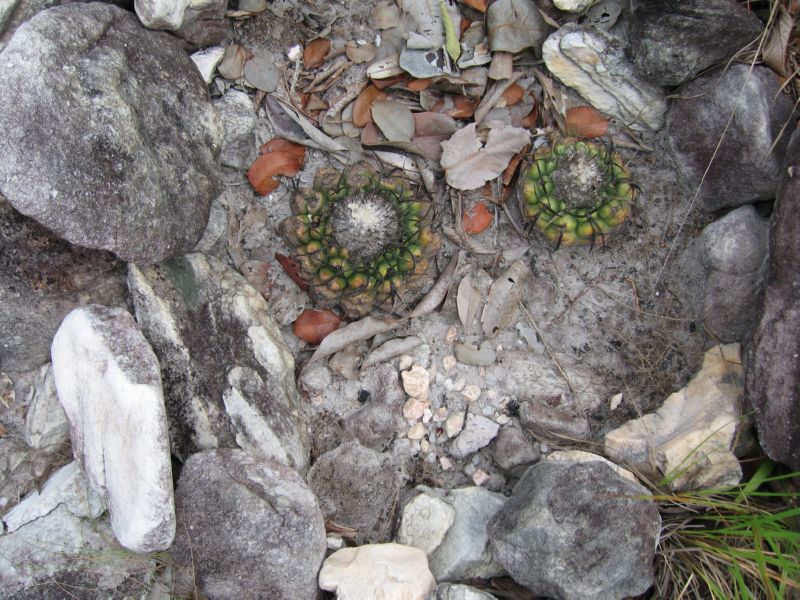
xmin=319 ymin=544 xmax=436 ymax=600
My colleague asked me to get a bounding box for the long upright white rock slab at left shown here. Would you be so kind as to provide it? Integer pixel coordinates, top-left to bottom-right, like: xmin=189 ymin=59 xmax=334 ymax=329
xmin=52 ymin=305 xmax=175 ymax=552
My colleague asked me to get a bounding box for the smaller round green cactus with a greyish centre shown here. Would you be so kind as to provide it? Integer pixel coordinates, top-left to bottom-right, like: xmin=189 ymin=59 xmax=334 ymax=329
xmin=522 ymin=138 xmax=636 ymax=247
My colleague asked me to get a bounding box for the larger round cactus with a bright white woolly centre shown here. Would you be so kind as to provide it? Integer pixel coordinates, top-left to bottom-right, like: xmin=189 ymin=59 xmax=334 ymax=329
xmin=281 ymin=164 xmax=441 ymax=317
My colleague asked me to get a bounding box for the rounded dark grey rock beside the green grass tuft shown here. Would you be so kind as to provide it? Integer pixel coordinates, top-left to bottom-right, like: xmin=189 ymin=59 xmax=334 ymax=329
xmin=488 ymin=461 xmax=661 ymax=600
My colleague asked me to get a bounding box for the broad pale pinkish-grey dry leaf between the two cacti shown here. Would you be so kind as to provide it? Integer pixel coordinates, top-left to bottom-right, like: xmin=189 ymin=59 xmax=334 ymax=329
xmin=441 ymin=123 xmax=530 ymax=190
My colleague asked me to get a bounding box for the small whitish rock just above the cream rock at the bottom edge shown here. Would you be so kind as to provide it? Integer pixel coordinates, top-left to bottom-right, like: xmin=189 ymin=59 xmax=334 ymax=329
xmin=397 ymin=492 xmax=456 ymax=556
